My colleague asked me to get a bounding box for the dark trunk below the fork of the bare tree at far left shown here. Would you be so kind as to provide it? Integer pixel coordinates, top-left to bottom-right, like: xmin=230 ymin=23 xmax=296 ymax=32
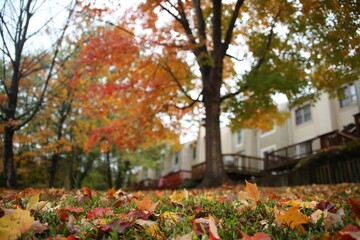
xmin=3 ymin=126 xmax=17 ymax=188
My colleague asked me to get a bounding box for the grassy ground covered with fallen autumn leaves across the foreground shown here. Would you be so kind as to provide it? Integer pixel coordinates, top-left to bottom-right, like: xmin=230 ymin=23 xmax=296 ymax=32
xmin=0 ymin=182 xmax=360 ymax=240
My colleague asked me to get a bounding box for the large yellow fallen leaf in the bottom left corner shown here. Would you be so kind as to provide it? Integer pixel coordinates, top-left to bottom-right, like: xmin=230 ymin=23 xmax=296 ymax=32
xmin=0 ymin=208 xmax=34 ymax=239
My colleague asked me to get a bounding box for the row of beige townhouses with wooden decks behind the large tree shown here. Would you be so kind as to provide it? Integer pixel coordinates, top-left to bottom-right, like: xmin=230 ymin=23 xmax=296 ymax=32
xmin=137 ymin=81 xmax=360 ymax=187
